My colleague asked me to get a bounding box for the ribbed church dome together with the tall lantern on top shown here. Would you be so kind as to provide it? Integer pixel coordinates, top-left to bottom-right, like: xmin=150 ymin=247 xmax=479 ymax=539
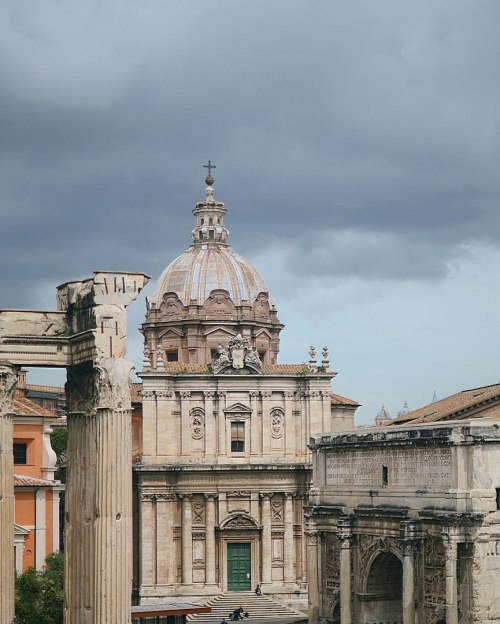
xmin=152 ymin=175 xmax=269 ymax=306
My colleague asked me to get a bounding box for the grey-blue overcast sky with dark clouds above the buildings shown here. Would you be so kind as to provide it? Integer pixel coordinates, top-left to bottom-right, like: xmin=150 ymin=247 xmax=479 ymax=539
xmin=0 ymin=0 xmax=500 ymax=424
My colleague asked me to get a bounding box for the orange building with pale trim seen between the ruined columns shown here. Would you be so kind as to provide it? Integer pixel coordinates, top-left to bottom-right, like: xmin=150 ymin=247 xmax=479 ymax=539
xmin=13 ymin=392 xmax=64 ymax=573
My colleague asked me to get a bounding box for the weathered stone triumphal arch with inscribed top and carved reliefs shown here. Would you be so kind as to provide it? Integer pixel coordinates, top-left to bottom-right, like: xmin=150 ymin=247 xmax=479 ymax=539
xmin=306 ymin=420 xmax=500 ymax=624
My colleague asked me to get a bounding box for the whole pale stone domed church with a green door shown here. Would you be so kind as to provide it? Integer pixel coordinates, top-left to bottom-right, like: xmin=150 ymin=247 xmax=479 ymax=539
xmin=134 ymin=173 xmax=358 ymax=604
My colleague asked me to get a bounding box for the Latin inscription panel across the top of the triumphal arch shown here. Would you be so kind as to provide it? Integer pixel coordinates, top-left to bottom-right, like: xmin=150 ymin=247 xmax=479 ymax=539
xmin=326 ymin=448 xmax=452 ymax=489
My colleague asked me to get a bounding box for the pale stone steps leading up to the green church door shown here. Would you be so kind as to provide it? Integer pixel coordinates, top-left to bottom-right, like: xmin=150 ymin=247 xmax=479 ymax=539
xmin=187 ymin=591 xmax=307 ymax=624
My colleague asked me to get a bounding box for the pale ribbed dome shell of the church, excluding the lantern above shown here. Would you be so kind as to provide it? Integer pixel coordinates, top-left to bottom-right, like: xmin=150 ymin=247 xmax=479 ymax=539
xmin=152 ymin=243 xmax=268 ymax=305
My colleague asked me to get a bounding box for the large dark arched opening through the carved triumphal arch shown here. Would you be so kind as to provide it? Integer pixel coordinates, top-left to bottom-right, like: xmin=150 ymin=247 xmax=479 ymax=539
xmin=362 ymin=552 xmax=403 ymax=624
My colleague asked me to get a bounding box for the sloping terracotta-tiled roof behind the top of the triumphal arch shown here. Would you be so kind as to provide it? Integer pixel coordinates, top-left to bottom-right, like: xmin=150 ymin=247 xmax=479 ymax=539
xmin=390 ymin=384 xmax=500 ymax=425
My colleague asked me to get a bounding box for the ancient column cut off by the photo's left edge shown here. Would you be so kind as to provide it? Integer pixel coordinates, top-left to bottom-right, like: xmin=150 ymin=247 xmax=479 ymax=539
xmin=0 ymin=364 xmax=18 ymax=624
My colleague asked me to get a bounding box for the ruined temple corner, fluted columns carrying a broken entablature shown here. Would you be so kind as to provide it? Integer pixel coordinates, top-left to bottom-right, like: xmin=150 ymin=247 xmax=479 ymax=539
xmin=0 ymin=271 xmax=149 ymax=624
